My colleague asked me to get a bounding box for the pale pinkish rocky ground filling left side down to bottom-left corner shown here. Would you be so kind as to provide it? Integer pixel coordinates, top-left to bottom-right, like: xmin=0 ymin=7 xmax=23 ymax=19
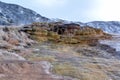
xmin=0 ymin=27 xmax=70 ymax=80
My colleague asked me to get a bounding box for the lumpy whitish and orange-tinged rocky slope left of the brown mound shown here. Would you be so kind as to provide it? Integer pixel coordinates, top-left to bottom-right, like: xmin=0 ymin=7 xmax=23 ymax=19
xmin=0 ymin=27 xmax=35 ymax=60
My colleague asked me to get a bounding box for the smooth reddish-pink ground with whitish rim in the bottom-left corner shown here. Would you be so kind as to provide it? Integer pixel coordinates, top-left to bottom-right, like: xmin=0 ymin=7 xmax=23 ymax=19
xmin=0 ymin=60 xmax=62 ymax=80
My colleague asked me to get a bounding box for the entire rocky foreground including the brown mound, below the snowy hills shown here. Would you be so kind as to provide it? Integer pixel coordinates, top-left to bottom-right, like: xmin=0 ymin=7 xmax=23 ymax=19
xmin=0 ymin=24 xmax=120 ymax=80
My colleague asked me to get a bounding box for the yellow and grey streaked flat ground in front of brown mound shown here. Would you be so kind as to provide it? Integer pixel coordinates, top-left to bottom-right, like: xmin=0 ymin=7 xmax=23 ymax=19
xmin=26 ymin=44 xmax=120 ymax=80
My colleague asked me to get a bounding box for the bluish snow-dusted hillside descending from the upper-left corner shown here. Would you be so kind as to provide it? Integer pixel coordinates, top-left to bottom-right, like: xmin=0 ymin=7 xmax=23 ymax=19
xmin=0 ymin=2 xmax=49 ymax=25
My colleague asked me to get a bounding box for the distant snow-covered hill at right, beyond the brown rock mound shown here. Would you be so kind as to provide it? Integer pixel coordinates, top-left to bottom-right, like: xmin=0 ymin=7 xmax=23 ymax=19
xmin=85 ymin=21 xmax=120 ymax=34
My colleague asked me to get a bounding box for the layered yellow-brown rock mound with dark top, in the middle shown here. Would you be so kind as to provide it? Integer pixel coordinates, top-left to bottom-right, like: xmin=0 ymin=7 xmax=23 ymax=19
xmin=22 ymin=23 xmax=111 ymax=44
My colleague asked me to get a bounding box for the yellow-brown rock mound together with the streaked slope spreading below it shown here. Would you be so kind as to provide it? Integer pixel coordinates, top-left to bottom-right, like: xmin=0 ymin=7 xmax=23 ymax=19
xmin=19 ymin=23 xmax=120 ymax=80
